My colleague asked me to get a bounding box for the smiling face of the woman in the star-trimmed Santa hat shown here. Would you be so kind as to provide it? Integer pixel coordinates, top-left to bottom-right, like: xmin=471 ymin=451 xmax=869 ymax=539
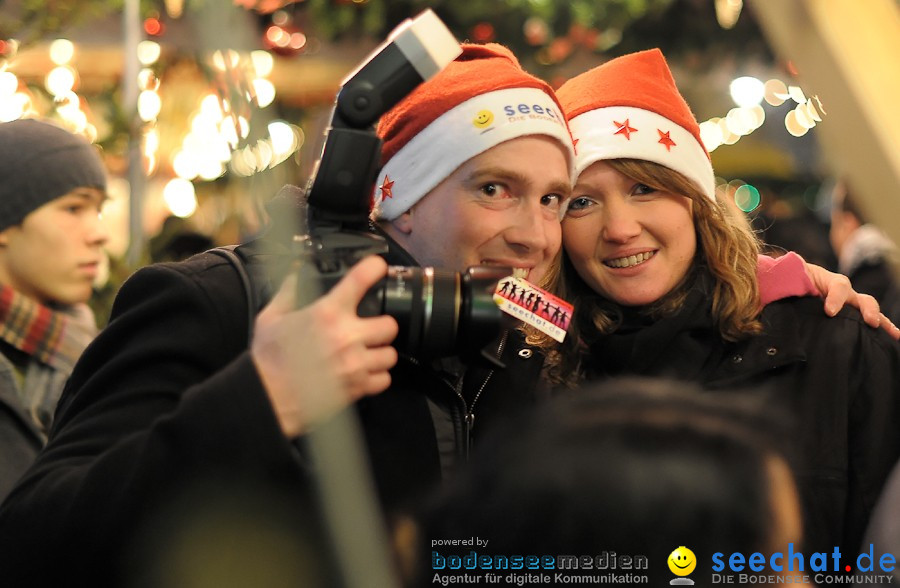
xmin=562 ymin=161 xmax=697 ymax=306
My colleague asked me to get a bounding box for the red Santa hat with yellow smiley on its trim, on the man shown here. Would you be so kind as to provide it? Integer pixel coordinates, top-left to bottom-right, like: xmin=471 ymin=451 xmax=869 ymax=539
xmin=373 ymin=43 xmax=574 ymax=220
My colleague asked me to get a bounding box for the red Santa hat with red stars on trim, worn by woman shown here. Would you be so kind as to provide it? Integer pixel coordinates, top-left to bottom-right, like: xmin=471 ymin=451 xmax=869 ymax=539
xmin=556 ymin=49 xmax=715 ymax=198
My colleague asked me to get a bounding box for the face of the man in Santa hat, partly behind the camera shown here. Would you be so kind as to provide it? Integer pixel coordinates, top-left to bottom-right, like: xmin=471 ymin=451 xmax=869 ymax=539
xmin=389 ymin=135 xmax=570 ymax=282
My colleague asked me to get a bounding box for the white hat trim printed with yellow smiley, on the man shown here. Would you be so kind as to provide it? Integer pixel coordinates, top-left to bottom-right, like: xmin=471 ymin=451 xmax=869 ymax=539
xmin=374 ymin=88 xmax=574 ymax=220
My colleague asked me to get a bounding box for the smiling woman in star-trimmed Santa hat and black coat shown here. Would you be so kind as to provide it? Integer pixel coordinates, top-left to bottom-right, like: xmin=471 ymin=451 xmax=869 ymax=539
xmin=531 ymin=50 xmax=900 ymax=553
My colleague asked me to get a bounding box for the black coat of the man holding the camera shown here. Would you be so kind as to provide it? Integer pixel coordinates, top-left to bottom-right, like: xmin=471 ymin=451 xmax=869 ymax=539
xmin=0 ymin=237 xmax=541 ymax=586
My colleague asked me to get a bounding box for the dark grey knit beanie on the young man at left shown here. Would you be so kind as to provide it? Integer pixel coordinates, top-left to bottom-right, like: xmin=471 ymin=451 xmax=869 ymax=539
xmin=0 ymin=119 xmax=106 ymax=230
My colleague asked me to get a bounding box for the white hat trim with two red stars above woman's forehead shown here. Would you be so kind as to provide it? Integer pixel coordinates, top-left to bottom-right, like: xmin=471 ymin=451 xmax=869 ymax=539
xmin=569 ymin=106 xmax=716 ymax=200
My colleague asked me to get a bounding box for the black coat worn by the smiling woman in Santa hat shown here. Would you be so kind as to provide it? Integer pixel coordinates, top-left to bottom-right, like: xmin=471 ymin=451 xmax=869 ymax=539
xmin=591 ymin=291 xmax=900 ymax=557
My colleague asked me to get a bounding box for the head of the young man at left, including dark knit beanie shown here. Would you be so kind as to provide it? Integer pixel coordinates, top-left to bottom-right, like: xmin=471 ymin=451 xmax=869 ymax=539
xmin=0 ymin=119 xmax=108 ymax=304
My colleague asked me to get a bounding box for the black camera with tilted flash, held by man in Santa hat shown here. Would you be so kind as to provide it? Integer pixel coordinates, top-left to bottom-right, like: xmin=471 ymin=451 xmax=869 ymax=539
xmin=294 ymin=10 xmax=511 ymax=363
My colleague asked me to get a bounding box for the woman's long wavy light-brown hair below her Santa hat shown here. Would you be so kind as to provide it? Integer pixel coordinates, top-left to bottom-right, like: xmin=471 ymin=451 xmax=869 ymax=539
xmin=525 ymin=159 xmax=762 ymax=385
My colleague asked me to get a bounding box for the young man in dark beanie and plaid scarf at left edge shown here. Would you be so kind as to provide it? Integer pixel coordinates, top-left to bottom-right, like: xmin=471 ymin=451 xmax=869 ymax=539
xmin=0 ymin=119 xmax=108 ymax=499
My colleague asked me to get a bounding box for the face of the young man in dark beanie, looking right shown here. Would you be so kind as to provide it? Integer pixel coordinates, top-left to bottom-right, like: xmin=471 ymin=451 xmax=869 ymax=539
xmin=0 ymin=188 xmax=108 ymax=304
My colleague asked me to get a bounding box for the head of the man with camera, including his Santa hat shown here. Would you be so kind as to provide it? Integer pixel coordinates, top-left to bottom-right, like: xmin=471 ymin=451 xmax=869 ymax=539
xmin=373 ymin=44 xmax=574 ymax=280
